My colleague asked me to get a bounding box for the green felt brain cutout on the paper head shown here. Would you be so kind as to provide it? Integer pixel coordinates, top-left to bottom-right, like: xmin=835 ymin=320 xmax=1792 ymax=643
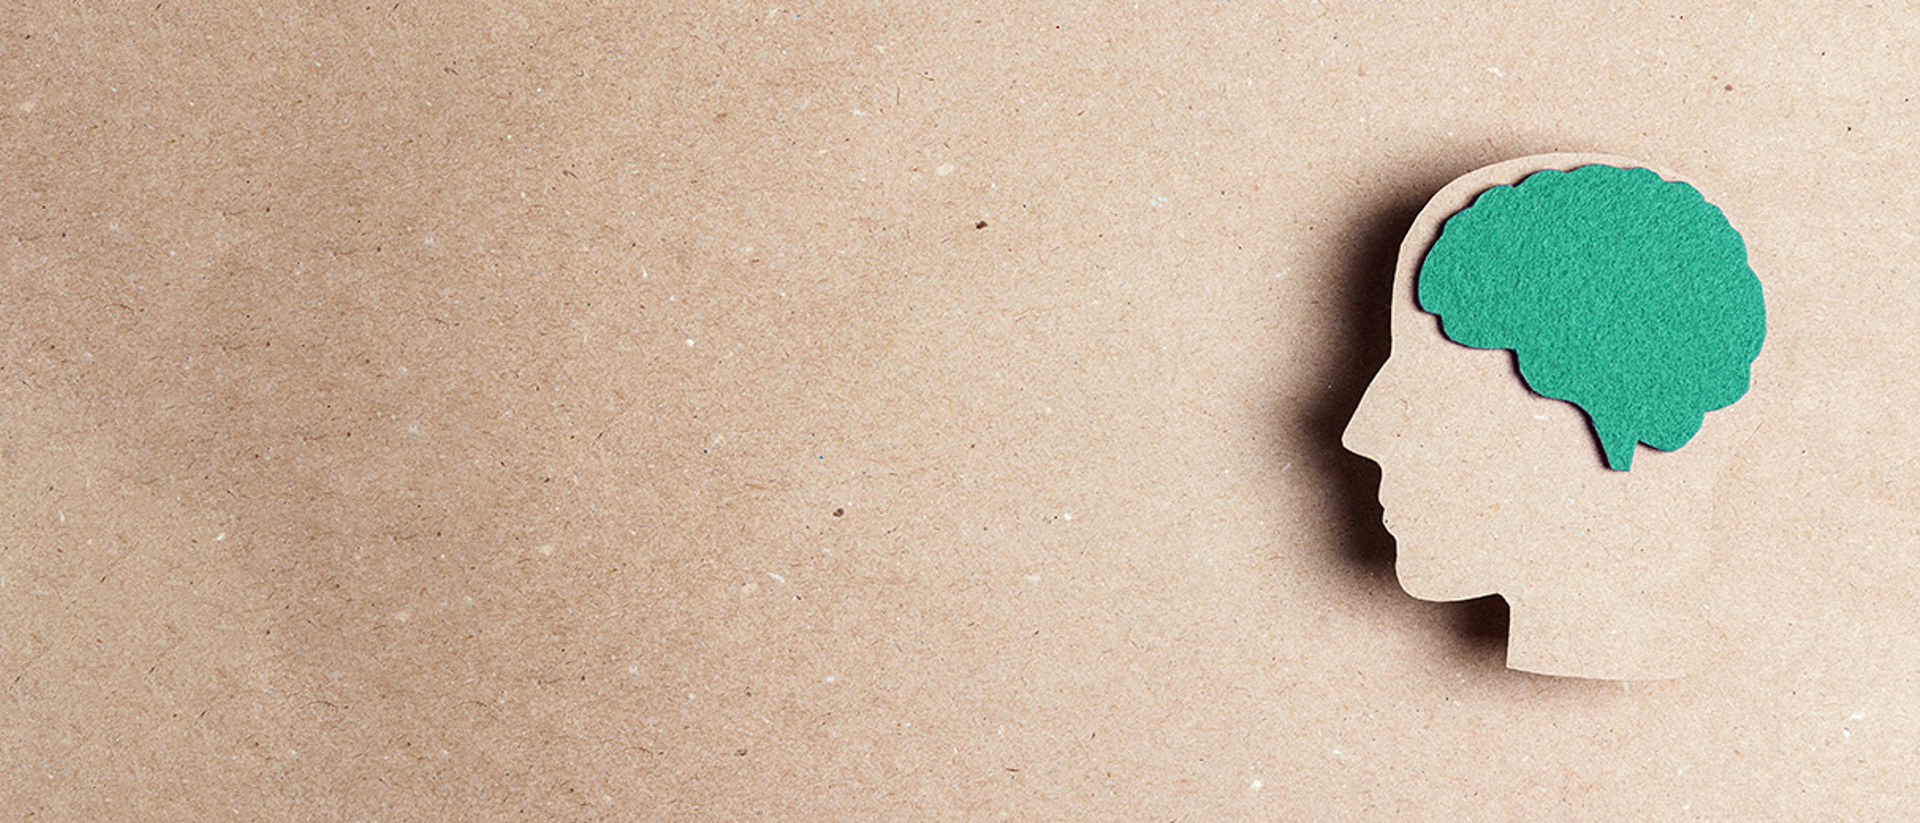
xmin=1417 ymin=165 xmax=1766 ymax=472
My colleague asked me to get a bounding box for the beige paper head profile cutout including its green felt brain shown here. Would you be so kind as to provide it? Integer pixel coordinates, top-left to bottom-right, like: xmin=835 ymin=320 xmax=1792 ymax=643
xmin=1344 ymin=153 xmax=1764 ymax=679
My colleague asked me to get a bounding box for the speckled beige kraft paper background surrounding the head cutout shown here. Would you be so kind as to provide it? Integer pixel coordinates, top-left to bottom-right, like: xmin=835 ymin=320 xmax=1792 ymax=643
xmin=0 ymin=0 xmax=1920 ymax=821
